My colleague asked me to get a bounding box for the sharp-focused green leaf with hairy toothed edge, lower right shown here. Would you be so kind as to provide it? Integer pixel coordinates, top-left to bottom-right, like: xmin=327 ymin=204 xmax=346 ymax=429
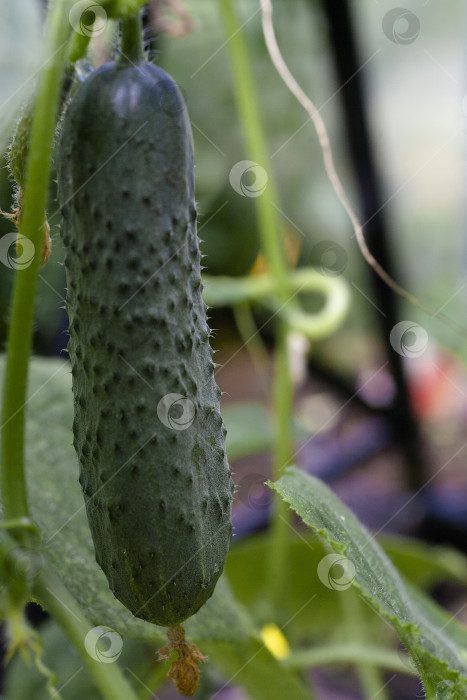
xmin=269 ymin=467 xmax=467 ymax=700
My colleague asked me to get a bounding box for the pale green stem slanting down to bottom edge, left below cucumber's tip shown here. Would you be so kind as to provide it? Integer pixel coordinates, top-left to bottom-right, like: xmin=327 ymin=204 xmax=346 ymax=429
xmin=34 ymin=566 xmax=138 ymax=700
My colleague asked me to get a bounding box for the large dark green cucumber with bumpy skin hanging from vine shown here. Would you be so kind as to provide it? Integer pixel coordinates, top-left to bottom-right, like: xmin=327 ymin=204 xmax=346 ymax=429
xmin=58 ymin=61 xmax=233 ymax=626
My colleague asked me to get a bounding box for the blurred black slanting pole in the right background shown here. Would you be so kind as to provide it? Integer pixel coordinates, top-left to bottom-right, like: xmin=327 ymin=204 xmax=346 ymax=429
xmin=318 ymin=0 xmax=424 ymax=489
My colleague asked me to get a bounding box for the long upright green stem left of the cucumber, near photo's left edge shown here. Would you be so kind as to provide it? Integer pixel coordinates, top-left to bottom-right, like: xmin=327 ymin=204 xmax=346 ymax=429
xmin=1 ymin=0 xmax=71 ymax=519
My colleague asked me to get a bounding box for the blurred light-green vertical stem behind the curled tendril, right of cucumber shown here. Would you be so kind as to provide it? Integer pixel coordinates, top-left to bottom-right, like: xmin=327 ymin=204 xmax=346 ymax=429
xmin=219 ymin=0 xmax=293 ymax=618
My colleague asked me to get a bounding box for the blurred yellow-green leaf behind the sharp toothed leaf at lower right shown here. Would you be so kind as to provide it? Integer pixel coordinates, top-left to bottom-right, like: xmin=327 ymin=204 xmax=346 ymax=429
xmin=226 ymin=533 xmax=467 ymax=647
